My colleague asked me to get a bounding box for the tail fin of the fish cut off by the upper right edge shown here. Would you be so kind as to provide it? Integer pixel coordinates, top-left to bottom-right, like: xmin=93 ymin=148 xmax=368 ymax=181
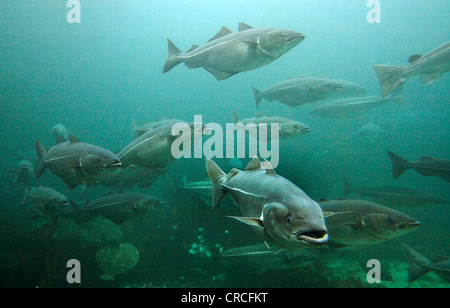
xmin=373 ymin=65 xmax=408 ymax=97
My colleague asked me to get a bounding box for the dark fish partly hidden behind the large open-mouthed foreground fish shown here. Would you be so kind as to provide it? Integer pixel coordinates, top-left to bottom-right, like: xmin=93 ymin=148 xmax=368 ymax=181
xmin=319 ymin=200 xmax=420 ymax=249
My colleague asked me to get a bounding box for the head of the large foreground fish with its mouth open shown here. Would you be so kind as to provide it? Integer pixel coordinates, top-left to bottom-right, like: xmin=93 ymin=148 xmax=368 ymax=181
xmin=261 ymin=198 xmax=328 ymax=248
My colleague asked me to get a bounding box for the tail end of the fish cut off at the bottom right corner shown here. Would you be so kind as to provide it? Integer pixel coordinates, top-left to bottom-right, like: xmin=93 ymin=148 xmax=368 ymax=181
xmin=402 ymin=243 xmax=450 ymax=283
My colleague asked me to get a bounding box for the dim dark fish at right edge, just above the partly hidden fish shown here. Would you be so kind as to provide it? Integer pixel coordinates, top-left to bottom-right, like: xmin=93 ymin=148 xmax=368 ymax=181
xmin=343 ymin=177 xmax=450 ymax=207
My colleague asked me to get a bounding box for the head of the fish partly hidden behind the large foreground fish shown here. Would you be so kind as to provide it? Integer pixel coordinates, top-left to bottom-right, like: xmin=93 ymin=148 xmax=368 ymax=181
xmin=361 ymin=213 xmax=420 ymax=240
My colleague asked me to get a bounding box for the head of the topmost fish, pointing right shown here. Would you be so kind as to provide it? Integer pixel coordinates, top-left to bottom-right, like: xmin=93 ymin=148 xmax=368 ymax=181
xmin=258 ymin=29 xmax=305 ymax=58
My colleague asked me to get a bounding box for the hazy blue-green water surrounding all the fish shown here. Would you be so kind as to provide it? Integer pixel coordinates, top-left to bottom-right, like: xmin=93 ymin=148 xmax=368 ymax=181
xmin=0 ymin=0 xmax=450 ymax=288
